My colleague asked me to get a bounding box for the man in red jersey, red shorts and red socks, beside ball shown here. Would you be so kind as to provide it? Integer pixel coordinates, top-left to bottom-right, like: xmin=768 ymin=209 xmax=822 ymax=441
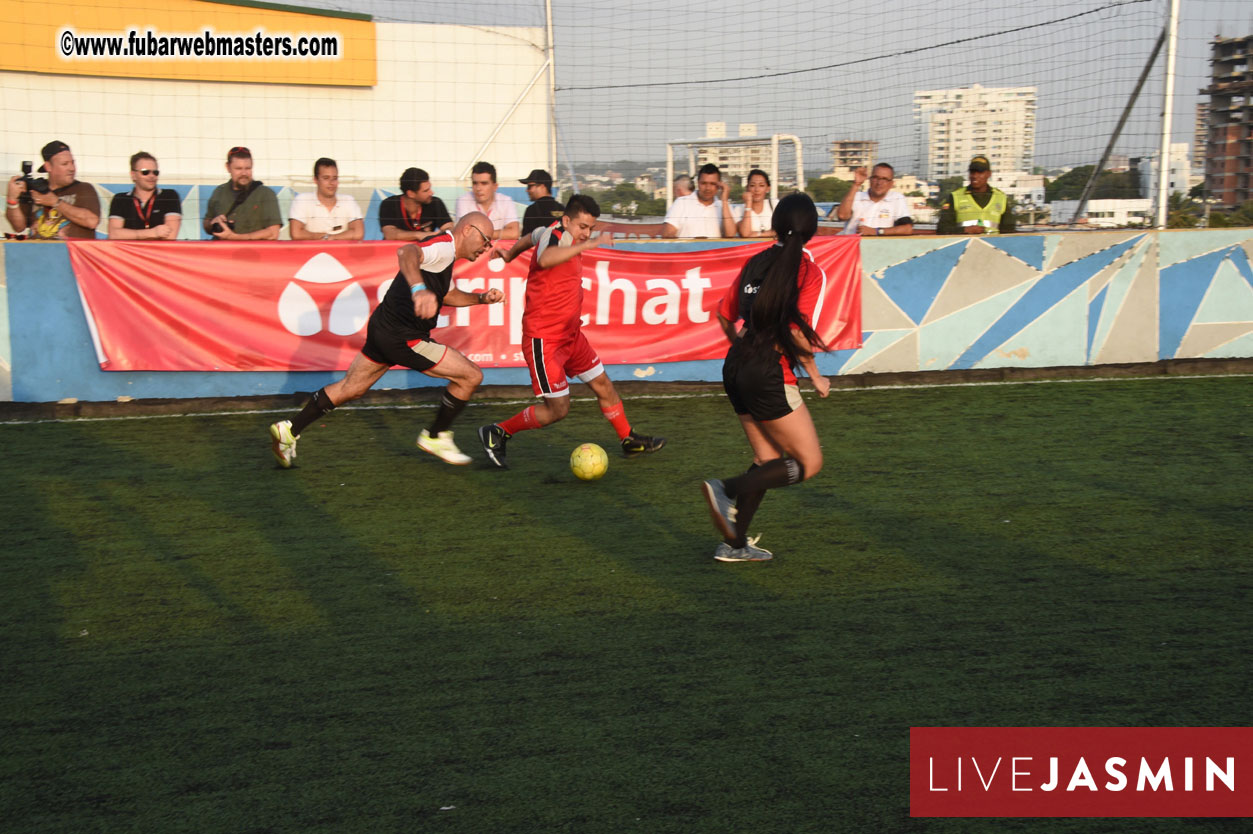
xmin=479 ymin=194 xmax=665 ymax=470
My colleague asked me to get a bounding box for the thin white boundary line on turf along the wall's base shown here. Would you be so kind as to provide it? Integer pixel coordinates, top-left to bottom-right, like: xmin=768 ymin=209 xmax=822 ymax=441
xmin=0 ymin=373 xmax=1253 ymax=426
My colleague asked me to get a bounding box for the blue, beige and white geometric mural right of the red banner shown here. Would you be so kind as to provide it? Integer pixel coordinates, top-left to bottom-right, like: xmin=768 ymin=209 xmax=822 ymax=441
xmin=819 ymin=229 xmax=1253 ymax=374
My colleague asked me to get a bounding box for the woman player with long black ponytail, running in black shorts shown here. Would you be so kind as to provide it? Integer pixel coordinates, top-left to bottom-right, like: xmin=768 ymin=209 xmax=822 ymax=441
xmin=704 ymin=194 xmax=831 ymax=562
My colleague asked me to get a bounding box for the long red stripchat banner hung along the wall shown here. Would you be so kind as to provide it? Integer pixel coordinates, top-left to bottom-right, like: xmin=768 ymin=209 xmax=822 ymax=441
xmin=69 ymin=237 xmax=861 ymax=371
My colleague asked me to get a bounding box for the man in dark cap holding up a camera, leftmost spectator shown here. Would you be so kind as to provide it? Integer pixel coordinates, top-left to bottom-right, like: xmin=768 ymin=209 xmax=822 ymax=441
xmin=5 ymin=142 xmax=100 ymax=240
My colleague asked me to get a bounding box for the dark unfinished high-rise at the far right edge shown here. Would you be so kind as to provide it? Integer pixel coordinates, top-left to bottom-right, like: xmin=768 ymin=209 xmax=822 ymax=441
xmin=1200 ymin=35 xmax=1253 ymax=207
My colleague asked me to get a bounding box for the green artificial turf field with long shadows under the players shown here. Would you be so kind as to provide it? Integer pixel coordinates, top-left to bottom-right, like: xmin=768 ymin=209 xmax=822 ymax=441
xmin=0 ymin=377 xmax=1253 ymax=834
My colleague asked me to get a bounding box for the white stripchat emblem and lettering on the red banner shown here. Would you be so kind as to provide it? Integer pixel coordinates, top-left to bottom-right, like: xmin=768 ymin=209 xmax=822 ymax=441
xmin=278 ymin=252 xmax=712 ymax=340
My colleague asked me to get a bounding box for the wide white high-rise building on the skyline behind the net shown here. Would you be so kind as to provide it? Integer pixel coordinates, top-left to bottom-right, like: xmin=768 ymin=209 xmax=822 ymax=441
xmin=913 ymin=84 xmax=1036 ymax=180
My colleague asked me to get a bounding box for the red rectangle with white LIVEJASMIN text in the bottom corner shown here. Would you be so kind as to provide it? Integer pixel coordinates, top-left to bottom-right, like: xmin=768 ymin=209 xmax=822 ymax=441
xmin=910 ymin=726 xmax=1253 ymax=816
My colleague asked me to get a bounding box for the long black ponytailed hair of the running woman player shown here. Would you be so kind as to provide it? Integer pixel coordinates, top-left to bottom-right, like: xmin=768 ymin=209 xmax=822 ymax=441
xmin=748 ymin=194 xmax=827 ymax=367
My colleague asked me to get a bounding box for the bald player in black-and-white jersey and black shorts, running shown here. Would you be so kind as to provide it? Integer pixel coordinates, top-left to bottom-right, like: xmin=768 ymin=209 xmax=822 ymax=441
xmin=269 ymin=212 xmax=505 ymax=470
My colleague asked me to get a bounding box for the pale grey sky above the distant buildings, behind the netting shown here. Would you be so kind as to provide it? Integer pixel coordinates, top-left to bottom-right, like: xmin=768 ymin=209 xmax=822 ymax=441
xmin=307 ymin=0 xmax=1253 ymax=170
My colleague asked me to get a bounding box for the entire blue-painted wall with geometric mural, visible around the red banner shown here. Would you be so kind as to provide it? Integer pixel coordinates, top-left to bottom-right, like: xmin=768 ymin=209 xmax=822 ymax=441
xmin=0 ymin=229 xmax=1253 ymax=402
